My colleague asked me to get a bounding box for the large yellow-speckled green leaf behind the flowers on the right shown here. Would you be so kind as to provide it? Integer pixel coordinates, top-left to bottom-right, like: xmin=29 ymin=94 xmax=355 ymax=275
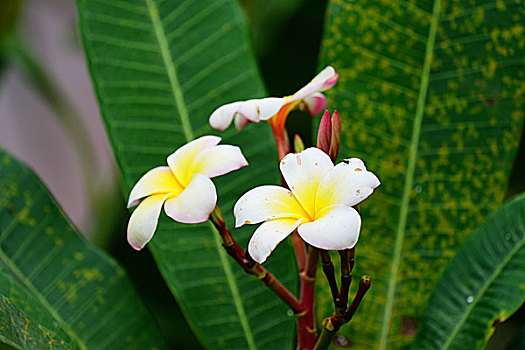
xmin=321 ymin=0 xmax=525 ymax=349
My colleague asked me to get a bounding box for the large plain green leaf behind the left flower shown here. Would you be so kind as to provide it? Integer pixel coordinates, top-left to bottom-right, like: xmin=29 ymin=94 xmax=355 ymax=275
xmin=77 ymin=0 xmax=296 ymax=349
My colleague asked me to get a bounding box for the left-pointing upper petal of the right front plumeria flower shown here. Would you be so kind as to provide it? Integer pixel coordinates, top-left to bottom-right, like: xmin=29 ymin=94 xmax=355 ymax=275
xmin=233 ymin=185 xmax=306 ymax=227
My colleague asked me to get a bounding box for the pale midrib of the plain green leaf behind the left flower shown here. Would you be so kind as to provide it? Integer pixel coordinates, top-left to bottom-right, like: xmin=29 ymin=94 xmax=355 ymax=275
xmin=145 ymin=0 xmax=257 ymax=350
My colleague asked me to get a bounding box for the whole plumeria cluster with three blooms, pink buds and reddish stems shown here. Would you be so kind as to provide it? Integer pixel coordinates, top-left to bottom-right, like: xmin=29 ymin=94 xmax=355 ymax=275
xmin=128 ymin=66 xmax=380 ymax=349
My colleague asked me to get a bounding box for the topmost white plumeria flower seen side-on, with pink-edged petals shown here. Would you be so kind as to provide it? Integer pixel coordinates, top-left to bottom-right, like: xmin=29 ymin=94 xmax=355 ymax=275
xmin=210 ymin=66 xmax=338 ymax=130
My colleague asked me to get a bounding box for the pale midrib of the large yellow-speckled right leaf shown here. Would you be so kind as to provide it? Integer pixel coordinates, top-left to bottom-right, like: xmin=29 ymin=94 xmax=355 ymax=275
xmin=379 ymin=0 xmax=441 ymax=350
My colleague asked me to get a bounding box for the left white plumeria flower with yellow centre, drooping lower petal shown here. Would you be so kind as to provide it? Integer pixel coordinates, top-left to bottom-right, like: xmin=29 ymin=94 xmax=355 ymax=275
xmin=128 ymin=136 xmax=248 ymax=250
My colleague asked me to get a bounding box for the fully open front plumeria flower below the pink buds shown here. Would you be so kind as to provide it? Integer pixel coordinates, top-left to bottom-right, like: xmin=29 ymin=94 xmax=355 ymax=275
xmin=233 ymin=148 xmax=380 ymax=263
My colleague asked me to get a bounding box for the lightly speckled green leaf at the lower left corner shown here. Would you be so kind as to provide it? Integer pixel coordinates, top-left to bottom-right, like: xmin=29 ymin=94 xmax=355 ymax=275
xmin=0 ymin=151 xmax=164 ymax=349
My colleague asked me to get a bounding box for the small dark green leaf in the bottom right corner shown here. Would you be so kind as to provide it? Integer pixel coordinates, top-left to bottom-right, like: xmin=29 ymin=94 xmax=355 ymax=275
xmin=414 ymin=195 xmax=525 ymax=350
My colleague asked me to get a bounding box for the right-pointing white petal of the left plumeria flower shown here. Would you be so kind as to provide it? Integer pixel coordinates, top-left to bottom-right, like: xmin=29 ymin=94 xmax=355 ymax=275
xmin=191 ymin=145 xmax=248 ymax=178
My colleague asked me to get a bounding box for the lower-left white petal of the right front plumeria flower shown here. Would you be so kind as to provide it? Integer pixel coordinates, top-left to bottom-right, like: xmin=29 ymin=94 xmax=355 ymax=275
xmin=248 ymin=219 xmax=303 ymax=264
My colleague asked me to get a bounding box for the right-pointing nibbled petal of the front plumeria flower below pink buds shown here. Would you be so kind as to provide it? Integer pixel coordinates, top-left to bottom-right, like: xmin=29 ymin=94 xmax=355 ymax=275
xmin=315 ymin=158 xmax=381 ymax=212
